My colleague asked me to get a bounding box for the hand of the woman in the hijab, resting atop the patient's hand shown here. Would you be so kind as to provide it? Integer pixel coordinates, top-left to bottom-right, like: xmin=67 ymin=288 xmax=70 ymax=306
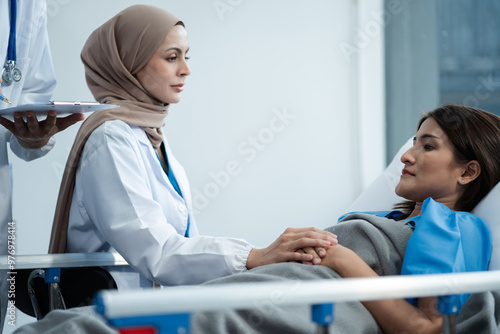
xmin=247 ymin=227 xmax=337 ymax=269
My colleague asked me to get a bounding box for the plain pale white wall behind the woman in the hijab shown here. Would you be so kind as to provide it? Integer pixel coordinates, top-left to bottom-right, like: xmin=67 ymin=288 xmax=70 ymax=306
xmin=11 ymin=0 xmax=384 ymax=254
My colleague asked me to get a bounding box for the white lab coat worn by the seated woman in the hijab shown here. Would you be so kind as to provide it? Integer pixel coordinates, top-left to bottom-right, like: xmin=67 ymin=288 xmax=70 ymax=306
xmin=68 ymin=120 xmax=253 ymax=289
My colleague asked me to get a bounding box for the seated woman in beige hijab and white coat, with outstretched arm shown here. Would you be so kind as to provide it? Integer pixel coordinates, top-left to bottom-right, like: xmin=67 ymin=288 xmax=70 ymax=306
xmin=49 ymin=5 xmax=337 ymax=289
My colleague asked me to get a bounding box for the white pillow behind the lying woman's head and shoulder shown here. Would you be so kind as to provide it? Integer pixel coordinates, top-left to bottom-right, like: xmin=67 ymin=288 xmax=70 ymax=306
xmin=346 ymin=137 xmax=500 ymax=270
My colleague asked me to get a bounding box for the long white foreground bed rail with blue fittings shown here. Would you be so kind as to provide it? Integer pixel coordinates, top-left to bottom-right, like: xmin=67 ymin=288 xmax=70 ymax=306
xmin=96 ymin=271 xmax=500 ymax=333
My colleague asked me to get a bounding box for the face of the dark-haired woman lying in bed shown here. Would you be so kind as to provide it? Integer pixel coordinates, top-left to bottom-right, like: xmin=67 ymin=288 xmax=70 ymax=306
xmin=396 ymin=118 xmax=465 ymax=208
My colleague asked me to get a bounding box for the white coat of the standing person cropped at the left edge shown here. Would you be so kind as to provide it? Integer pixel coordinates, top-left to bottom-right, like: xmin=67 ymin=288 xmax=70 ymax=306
xmin=0 ymin=0 xmax=56 ymax=331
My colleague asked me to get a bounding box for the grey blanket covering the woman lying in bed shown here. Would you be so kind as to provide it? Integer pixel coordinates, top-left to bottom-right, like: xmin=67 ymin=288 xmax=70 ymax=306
xmin=10 ymin=214 xmax=500 ymax=334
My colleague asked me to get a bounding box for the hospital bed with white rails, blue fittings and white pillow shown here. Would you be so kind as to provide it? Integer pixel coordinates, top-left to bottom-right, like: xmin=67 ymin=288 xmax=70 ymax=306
xmin=0 ymin=140 xmax=500 ymax=334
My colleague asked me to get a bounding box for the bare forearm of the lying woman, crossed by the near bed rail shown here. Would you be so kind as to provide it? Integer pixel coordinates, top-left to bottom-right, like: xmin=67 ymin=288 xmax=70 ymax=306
xmin=322 ymin=245 xmax=442 ymax=333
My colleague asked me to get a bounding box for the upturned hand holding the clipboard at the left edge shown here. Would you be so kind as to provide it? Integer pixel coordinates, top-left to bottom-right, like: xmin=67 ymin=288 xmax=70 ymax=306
xmin=0 ymin=110 xmax=85 ymax=149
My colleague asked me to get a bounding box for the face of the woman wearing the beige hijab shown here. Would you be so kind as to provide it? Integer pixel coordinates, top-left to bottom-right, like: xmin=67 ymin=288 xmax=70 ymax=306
xmin=137 ymin=25 xmax=191 ymax=103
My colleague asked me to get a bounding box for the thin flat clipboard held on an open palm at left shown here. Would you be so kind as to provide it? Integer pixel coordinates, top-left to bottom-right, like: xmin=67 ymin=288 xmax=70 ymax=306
xmin=0 ymin=101 xmax=118 ymax=120
